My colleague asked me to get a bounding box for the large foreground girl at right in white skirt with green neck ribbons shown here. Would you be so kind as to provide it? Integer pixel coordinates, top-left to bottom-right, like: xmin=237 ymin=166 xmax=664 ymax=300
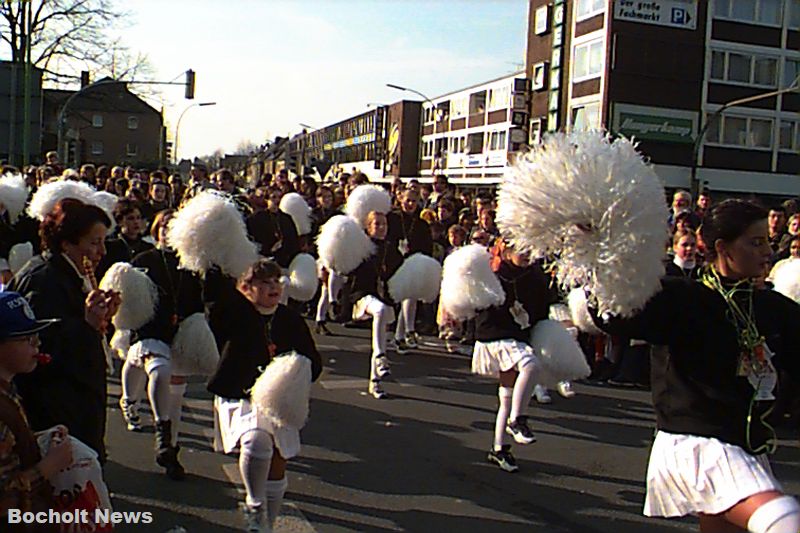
xmin=597 ymin=200 xmax=800 ymax=533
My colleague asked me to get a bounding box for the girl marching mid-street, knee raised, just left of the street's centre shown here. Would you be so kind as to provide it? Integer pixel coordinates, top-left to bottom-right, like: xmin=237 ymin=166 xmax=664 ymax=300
xmin=348 ymin=211 xmax=403 ymax=399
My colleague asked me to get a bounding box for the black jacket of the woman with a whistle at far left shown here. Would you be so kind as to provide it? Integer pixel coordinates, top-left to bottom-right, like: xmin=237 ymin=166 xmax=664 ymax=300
xmin=11 ymin=254 xmax=106 ymax=460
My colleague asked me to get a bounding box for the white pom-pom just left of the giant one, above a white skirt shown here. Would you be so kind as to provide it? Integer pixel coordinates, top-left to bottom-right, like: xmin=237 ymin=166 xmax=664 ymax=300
xmin=439 ymin=244 xmax=506 ymax=320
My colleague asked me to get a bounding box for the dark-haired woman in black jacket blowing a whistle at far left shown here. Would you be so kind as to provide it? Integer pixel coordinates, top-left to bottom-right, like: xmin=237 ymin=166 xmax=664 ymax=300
xmin=11 ymin=198 xmax=119 ymax=463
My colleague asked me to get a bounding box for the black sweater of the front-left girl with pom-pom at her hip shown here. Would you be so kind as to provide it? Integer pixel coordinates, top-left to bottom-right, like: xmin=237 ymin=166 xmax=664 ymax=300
xmin=208 ymin=289 xmax=322 ymax=399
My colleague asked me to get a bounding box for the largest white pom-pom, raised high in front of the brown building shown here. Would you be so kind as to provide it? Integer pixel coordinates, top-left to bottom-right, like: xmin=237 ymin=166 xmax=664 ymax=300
xmin=497 ymin=132 xmax=668 ymax=316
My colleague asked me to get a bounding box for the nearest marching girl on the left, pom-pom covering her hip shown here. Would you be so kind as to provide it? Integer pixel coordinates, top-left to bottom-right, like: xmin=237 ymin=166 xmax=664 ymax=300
xmin=208 ymin=259 xmax=322 ymax=532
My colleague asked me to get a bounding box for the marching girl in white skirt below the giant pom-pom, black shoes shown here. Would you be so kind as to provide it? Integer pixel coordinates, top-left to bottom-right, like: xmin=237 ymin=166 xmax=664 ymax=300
xmin=472 ymin=241 xmax=555 ymax=472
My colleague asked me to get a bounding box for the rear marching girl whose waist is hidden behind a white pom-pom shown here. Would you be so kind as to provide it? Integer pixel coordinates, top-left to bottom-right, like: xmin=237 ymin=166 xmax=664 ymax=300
xmin=387 ymin=189 xmax=433 ymax=354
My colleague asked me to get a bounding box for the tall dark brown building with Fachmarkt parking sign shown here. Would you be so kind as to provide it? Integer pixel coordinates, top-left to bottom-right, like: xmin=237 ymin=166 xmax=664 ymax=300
xmin=526 ymin=0 xmax=800 ymax=196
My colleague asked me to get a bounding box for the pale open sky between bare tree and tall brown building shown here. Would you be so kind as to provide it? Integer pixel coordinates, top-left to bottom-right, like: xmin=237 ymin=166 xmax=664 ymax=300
xmin=121 ymin=0 xmax=528 ymax=157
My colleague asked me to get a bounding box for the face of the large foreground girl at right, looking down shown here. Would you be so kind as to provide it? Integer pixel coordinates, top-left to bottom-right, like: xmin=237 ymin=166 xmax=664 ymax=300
xmin=714 ymin=220 xmax=772 ymax=279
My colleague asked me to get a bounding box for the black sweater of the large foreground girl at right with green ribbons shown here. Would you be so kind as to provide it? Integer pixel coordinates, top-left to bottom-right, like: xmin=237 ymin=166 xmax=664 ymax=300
xmin=595 ymin=277 xmax=800 ymax=452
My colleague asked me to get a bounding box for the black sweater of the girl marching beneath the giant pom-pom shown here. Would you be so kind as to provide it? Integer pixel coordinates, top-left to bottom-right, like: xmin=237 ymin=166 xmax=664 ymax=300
xmin=475 ymin=261 xmax=558 ymax=343
